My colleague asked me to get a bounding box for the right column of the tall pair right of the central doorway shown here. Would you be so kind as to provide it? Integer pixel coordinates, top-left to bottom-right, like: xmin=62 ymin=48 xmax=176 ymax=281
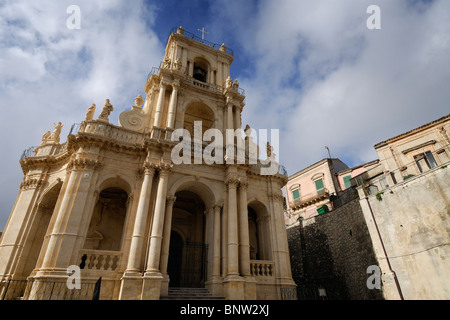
xmin=239 ymin=181 xmax=250 ymax=277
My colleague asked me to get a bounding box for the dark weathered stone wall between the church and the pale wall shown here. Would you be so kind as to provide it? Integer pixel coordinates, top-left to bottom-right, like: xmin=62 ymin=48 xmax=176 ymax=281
xmin=287 ymin=199 xmax=382 ymax=299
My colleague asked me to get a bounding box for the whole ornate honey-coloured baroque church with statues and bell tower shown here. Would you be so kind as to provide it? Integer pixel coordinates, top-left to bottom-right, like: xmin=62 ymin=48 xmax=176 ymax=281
xmin=0 ymin=27 xmax=296 ymax=300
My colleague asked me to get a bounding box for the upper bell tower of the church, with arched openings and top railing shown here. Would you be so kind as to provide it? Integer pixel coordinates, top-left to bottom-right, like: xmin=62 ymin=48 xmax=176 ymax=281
xmin=119 ymin=27 xmax=245 ymax=139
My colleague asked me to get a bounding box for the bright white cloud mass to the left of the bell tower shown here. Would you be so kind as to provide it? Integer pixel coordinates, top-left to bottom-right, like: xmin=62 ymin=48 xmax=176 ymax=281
xmin=0 ymin=0 xmax=164 ymax=230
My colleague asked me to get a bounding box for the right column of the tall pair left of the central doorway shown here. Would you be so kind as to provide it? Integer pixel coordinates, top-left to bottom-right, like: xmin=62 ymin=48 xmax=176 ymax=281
xmin=146 ymin=165 xmax=170 ymax=273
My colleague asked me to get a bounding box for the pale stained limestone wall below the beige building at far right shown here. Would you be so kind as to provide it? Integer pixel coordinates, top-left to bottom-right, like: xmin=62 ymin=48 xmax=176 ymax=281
xmin=361 ymin=166 xmax=450 ymax=300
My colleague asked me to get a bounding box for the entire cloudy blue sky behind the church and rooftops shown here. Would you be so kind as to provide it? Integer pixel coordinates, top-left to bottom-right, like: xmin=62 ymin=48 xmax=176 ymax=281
xmin=0 ymin=0 xmax=450 ymax=230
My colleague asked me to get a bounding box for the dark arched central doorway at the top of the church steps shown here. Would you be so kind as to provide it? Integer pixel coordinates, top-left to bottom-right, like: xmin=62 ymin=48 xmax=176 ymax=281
xmin=167 ymin=191 xmax=207 ymax=288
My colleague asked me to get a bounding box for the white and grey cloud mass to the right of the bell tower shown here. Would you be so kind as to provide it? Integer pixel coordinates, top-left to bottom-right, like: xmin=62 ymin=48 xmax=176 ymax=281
xmin=209 ymin=0 xmax=450 ymax=174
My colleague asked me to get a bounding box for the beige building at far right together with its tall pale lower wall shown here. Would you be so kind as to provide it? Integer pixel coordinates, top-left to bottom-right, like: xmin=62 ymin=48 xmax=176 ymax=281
xmin=355 ymin=115 xmax=450 ymax=300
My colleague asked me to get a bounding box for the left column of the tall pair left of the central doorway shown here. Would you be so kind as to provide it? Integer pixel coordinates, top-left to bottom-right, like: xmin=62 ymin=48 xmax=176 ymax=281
xmin=126 ymin=162 xmax=155 ymax=272
